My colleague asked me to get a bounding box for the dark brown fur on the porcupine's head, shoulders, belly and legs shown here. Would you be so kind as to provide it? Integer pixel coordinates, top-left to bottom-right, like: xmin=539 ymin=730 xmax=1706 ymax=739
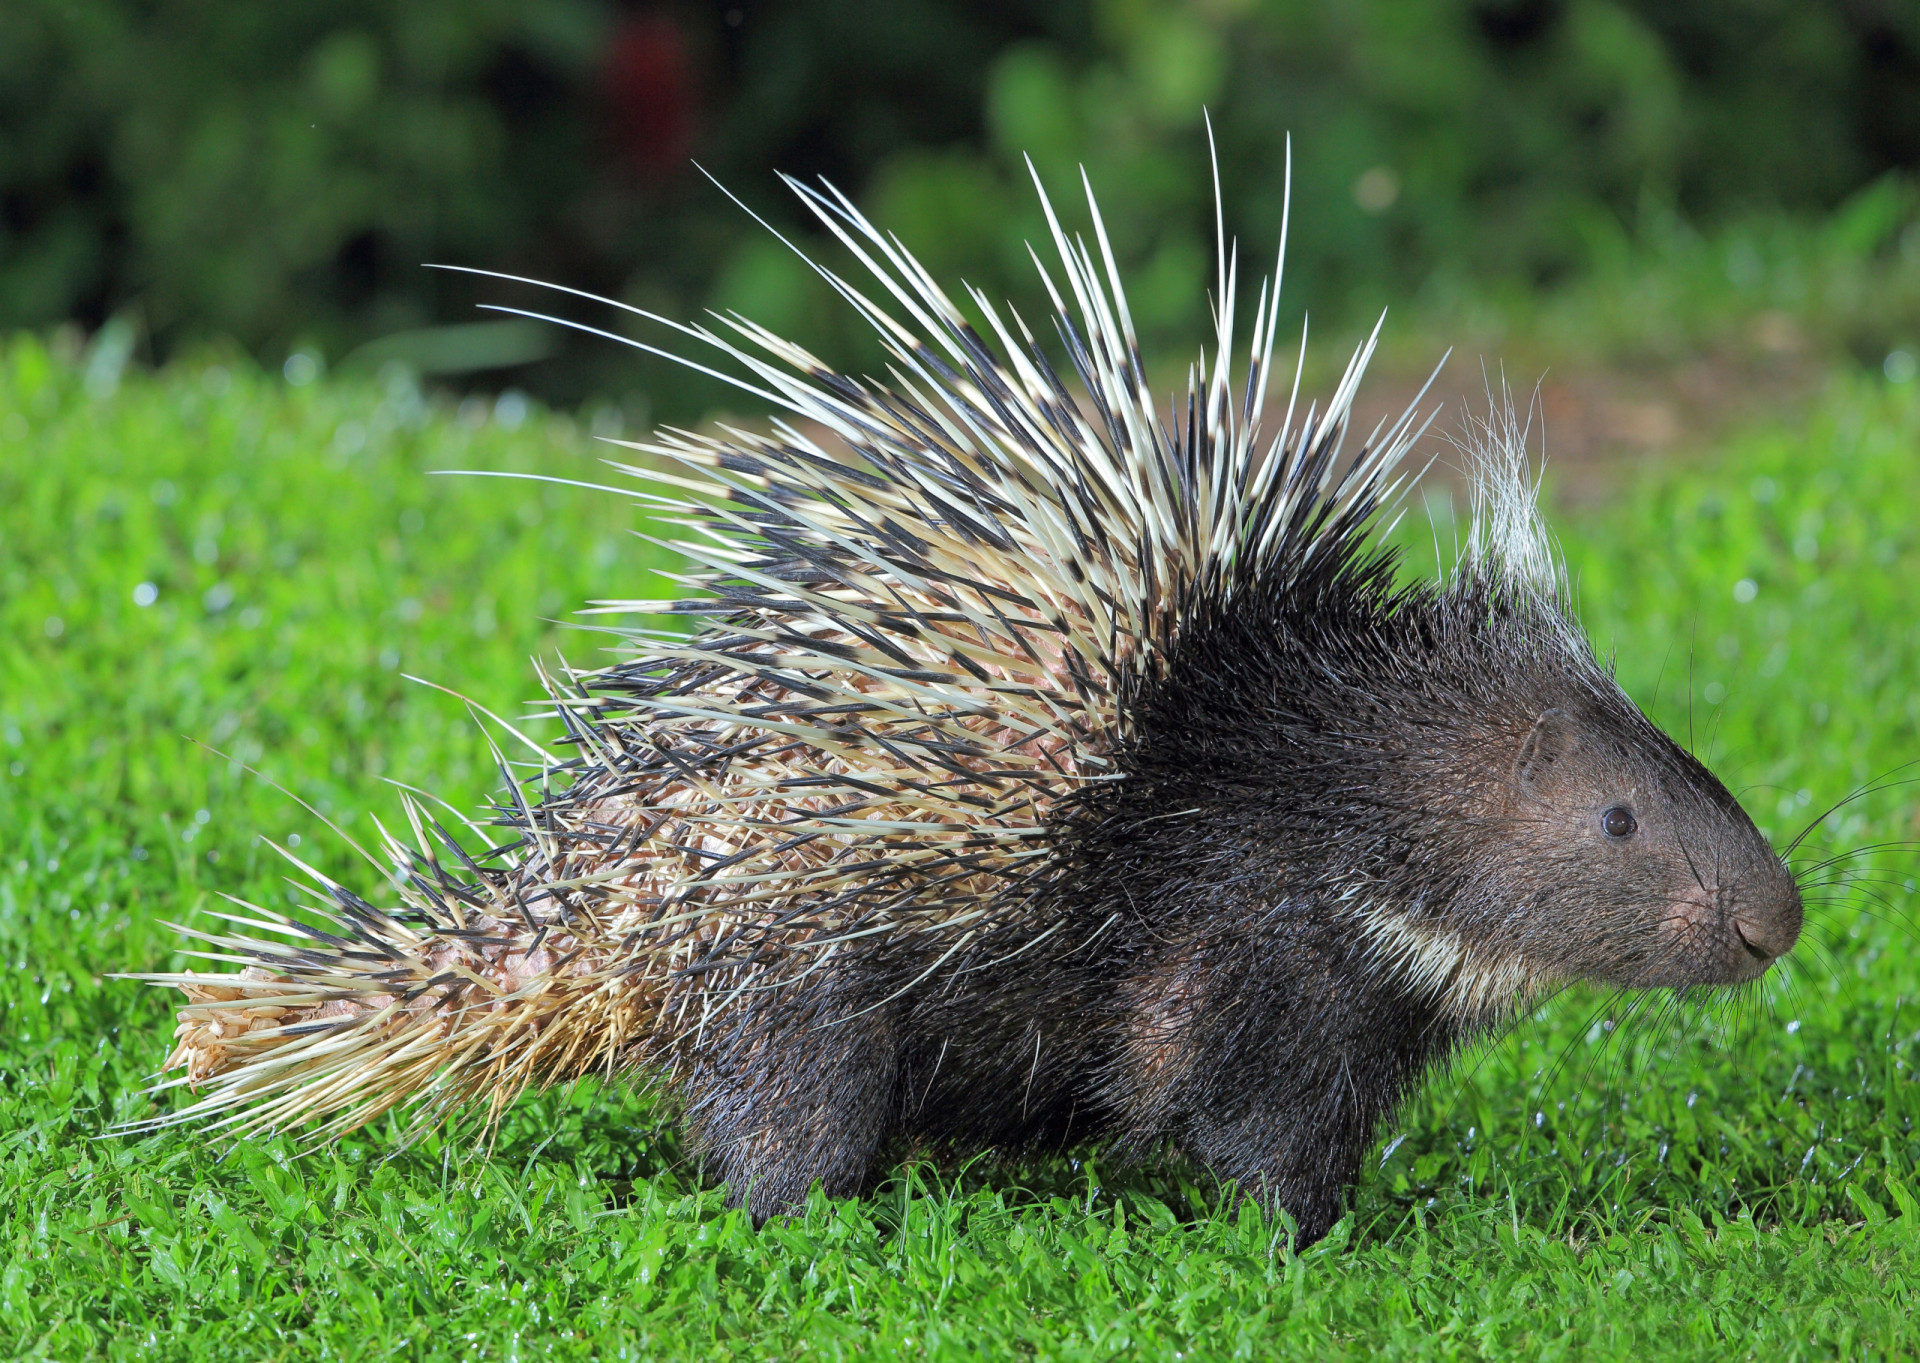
xmin=652 ymin=555 xmax=1801 ymax=1240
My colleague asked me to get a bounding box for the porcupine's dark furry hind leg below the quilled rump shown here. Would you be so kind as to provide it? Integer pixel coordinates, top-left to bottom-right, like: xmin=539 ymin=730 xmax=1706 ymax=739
xmin=684 ymin=1008 xmax=899 ymax=1225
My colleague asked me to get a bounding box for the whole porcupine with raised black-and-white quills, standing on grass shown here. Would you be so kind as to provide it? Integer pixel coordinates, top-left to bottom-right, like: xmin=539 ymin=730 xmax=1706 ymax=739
xmin=131 ymin=154 xmax=1801 ymax=1240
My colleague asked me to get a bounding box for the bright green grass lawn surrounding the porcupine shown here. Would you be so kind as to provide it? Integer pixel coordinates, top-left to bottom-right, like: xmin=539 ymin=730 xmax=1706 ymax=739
xmin=0 ymin=340 xmax=1920 ymax=1359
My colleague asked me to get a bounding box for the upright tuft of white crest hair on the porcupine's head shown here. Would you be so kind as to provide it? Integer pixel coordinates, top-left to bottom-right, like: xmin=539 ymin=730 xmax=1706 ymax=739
xmin=1453 ymin=380 xmax=1565 ymax=597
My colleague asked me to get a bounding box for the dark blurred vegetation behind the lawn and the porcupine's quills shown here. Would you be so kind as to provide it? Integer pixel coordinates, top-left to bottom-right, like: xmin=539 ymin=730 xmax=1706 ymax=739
xmin=0 ymin=0 xmax=1920 ymax=417
